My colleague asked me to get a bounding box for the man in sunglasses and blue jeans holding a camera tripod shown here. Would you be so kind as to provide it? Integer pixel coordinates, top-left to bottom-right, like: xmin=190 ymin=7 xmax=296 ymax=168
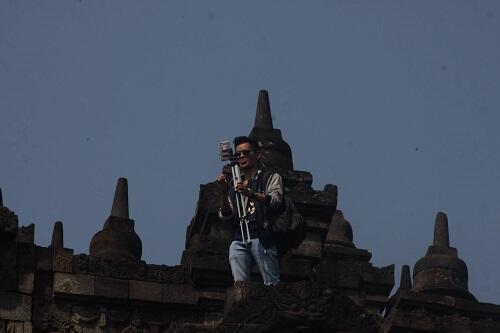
xmin=217 ymin=136 xmax=283 ymax=286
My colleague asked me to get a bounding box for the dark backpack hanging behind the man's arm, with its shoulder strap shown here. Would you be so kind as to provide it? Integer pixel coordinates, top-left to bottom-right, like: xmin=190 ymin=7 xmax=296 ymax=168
xmin=260 ymin=169 xmax=306 ymax=254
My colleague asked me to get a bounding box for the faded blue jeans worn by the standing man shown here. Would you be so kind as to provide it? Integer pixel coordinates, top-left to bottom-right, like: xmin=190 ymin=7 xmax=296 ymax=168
xmin=229 ymin=238 xmax=280 ymax=286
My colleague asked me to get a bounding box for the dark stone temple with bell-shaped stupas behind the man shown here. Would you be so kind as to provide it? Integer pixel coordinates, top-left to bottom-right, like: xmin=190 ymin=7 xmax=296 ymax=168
xmin=0 ymin=91 xmax=500 ymax=333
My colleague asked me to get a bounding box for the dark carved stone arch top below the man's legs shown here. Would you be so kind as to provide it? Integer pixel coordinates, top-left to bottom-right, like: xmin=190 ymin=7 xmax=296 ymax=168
xmin=218 ymin=281 xmax=378 ymax=333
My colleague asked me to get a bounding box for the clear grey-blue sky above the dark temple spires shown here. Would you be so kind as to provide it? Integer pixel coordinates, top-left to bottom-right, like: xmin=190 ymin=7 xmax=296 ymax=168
xmin=0 ymin=0 xmax=500 ymax=303
